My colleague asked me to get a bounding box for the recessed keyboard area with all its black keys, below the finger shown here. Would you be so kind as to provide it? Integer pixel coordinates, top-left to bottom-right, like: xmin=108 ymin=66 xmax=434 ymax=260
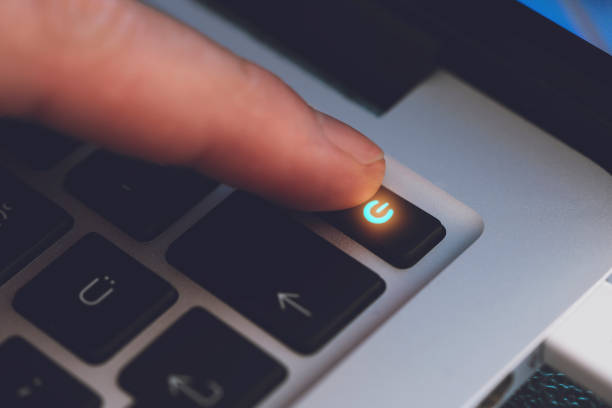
xmin=0 ymin=117 xmax=479 ymax=408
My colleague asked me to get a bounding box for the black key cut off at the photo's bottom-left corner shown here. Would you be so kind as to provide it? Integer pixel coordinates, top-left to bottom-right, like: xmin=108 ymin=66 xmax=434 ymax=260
xmin=0 ymin=337 xmax=101 ymax=408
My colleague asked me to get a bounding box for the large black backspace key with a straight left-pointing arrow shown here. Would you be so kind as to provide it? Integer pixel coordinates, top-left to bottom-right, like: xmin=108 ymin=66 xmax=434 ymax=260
xmin=167 ymin=192 xmax=385 ymax=353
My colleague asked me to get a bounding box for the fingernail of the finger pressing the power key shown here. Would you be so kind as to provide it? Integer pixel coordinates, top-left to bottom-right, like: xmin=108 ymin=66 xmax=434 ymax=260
xmin=316 ymin=111 xmax=385 ymax=164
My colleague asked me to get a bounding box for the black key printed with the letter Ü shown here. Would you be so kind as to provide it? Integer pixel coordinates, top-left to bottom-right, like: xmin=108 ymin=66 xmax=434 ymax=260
xmin=13 ymin=234 xmax=178 ymax=363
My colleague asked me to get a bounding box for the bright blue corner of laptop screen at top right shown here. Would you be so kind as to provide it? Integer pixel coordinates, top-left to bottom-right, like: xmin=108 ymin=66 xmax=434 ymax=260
xmin=518 ymin=0 xmax=612 ymax=54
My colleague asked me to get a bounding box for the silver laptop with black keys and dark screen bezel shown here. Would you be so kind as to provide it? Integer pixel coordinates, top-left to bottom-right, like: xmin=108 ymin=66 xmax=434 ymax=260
xmin=0 ymin=0 xmax=612 ymax=408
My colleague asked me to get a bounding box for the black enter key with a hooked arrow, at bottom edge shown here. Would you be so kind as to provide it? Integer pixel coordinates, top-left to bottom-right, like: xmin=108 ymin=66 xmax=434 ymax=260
xmin=119 ymin=308 xmax=287 ymax=408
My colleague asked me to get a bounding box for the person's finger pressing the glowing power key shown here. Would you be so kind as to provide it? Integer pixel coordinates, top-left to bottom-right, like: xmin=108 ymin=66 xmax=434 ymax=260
xmin=0 ymin=0 xmax=385 ymax=210
